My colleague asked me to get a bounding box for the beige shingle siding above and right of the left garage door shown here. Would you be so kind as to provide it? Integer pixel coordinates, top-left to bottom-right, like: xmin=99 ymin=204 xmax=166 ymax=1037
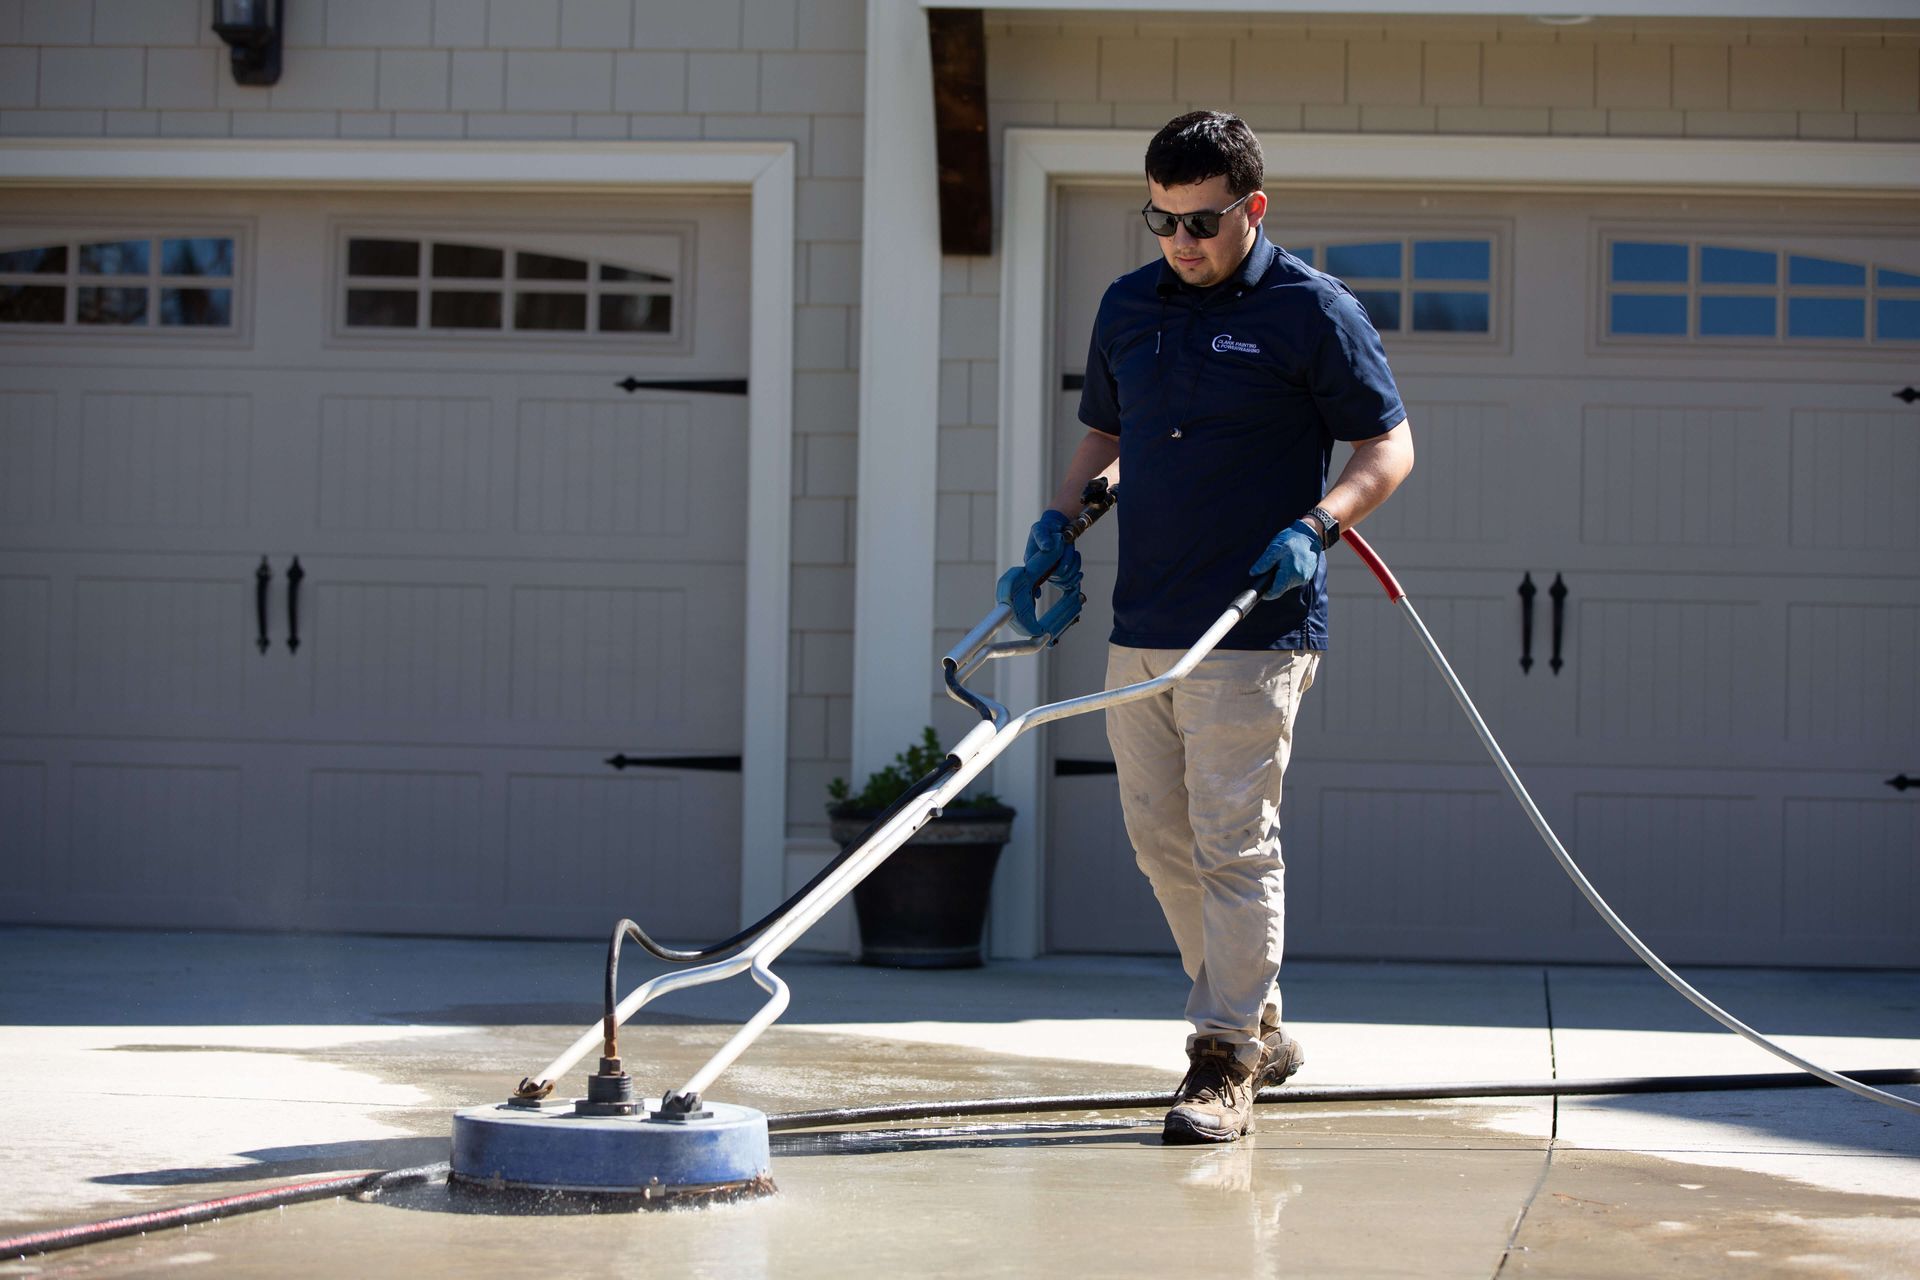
xmin=0 ymin=0 xmax=866 ymax=833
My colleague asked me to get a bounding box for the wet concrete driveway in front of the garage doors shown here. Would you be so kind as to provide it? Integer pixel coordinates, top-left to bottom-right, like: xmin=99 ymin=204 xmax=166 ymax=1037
xmin=0 ymin=931 xmax=1920 ymax=1276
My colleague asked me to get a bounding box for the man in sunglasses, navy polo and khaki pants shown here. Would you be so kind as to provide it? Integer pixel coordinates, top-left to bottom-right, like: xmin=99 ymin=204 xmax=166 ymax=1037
xmin=1027 ymin=111 xmax=1413 ymax=1142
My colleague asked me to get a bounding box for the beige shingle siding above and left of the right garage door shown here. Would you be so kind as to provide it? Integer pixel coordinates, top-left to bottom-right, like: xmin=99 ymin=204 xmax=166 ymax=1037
xmin=935 ymin=13 xmax=1920 ymax=752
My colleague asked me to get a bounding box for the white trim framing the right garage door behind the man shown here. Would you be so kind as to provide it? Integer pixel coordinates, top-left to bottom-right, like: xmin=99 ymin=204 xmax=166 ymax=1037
xmin=993 ymin=129 xmax=1920 ymax=956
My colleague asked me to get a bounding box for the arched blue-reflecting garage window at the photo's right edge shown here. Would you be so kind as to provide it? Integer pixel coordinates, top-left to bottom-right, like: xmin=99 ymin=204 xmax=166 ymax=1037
xmin=1603 ymin=238 xmax=1920 ymax=347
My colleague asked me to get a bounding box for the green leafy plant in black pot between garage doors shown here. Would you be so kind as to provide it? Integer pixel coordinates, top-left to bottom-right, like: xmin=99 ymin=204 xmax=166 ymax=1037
xmin=828 ymin=725 xmax=1014 ymax=969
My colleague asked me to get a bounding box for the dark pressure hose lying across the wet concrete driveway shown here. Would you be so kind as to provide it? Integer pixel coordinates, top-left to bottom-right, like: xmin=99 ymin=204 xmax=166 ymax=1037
xmin=0 ymin=1067 xmax=1920 ymax=1257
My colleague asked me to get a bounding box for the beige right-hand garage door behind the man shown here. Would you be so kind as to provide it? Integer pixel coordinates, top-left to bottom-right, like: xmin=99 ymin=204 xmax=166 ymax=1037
xmin=1046 ymin=186 xmax=1920 ymax=965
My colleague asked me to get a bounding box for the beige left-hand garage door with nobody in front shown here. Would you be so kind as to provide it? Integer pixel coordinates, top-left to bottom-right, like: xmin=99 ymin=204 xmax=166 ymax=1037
xmin=0 ymin=192 xmax=747 ymax=935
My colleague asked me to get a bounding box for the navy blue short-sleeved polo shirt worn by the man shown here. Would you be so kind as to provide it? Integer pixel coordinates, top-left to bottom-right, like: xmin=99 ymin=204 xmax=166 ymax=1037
xmin=1079 ymin=232 xmax=1407 ymax=649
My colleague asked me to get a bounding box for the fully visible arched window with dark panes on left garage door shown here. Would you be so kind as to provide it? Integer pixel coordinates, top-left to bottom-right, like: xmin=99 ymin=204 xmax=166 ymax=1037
xmin=340 ymin=234 xmax=678 ymax=338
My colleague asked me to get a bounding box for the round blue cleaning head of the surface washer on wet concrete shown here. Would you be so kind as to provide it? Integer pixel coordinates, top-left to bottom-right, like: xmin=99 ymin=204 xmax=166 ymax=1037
xmin=449 ymin=1102 xmax=774 ymax=1209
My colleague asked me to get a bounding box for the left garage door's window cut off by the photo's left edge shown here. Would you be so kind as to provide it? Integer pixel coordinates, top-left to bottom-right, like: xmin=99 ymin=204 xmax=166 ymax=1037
xmin=0 ymin=234 xmax=236 ymax=332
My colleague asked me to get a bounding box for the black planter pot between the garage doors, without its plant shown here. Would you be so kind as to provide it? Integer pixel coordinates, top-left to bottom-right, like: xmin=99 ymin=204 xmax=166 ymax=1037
xmin=831 ymin=808 xmax=1014 ymax=969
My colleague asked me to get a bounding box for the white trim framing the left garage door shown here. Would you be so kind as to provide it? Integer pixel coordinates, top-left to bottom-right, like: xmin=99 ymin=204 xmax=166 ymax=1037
xmin=0 ymin=138 xmax=795 ymax=921
